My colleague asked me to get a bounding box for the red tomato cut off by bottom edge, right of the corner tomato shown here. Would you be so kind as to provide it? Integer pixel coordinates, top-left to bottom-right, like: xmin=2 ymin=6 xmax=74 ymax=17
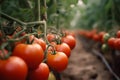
xmin=28 ymin=63 xmax=50 ymax=80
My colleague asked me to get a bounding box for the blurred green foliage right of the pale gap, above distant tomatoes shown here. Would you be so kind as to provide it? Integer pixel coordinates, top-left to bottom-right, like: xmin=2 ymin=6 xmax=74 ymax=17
xmin=79 ymin=0 xmax=120 ymax=31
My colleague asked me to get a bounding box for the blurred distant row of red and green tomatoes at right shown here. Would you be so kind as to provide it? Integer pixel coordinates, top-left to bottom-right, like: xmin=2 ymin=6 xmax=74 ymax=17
xmin=79 ymin=29 xmax=120 ymax=50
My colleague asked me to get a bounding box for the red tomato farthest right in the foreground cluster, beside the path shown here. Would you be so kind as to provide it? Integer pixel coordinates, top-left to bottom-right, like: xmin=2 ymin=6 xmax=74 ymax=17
xmin=61 ymin=35 xmax=76 ymax=49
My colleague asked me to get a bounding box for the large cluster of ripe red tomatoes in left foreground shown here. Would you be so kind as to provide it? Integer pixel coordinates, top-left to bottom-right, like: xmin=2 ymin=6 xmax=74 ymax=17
xmin=0 ymin=28 xmax=76 ymax=80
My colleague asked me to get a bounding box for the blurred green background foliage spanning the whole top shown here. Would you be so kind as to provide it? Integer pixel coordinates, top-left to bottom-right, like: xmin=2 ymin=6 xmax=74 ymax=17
xmin=0 ymin=0 xmax=120 ymax=30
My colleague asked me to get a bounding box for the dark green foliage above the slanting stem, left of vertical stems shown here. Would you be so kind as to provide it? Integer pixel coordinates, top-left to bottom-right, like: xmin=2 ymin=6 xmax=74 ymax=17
xmin=0 ymin=0 xmax=34 ymax=21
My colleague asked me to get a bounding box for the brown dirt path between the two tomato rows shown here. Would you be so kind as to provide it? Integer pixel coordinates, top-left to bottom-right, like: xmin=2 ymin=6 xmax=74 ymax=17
xmin=61 ymin=37 xmax=113 ymax=80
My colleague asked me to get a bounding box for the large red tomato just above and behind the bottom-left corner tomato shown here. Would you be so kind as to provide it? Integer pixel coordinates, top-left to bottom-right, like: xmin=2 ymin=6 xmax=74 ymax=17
xmin=12 ymin=44 xmax=44 ymax=69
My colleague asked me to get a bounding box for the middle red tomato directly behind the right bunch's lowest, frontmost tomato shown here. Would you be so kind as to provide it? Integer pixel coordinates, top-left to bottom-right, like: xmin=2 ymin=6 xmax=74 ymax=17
xmin=55 ymin=43 xmax=71 ymax=57
